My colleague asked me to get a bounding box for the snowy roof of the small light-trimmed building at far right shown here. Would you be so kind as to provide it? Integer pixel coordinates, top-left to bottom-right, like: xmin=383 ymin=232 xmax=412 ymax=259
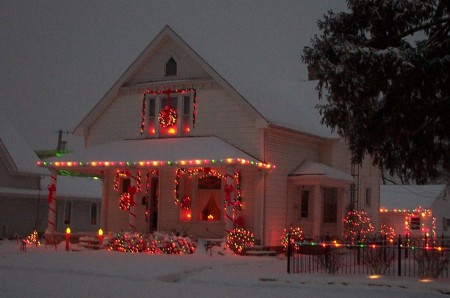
xmin=380 ymin=184 xmax=446 ymax=210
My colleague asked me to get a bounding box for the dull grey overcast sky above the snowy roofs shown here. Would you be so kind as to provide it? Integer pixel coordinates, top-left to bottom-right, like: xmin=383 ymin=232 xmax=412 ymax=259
xmin=0 ymin=0 xmax=345 ymax=149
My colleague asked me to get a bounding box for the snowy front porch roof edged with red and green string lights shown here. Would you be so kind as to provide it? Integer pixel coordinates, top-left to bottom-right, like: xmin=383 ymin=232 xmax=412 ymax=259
xmin=37 ymin=136 xmax=275 ymax=170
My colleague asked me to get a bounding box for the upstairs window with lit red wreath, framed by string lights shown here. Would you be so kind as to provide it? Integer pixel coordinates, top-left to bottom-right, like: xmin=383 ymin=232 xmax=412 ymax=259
xmin=146 ymin=92 xmax=194 ymax=137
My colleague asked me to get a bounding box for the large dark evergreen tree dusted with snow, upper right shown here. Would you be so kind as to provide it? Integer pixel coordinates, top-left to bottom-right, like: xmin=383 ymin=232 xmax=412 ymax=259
xmin=302 ymin=0 xmax=450 ymax=183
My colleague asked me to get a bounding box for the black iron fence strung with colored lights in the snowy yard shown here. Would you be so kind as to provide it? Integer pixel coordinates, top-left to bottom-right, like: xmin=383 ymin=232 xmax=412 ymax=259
xmin=287 ymin=237 xmax=450 ymax=279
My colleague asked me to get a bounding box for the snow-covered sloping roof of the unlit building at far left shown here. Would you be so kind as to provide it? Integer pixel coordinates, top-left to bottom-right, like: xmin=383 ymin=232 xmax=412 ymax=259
xmin=0 ymin=112 xmax=50 ymax=176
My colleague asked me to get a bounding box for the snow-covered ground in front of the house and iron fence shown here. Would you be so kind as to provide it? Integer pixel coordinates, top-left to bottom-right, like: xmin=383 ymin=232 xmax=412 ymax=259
xmin=0 ymin=240 xmax=450 ymax=298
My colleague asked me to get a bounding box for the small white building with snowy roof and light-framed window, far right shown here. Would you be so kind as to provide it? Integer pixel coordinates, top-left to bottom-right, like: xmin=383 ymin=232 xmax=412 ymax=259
xmin=380 ymin=185 xmax=450 ymax=238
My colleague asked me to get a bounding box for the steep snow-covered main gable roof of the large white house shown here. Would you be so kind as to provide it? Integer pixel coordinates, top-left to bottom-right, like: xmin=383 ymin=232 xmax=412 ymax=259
xmin=75 ymin=21 xmax=337 ymax=138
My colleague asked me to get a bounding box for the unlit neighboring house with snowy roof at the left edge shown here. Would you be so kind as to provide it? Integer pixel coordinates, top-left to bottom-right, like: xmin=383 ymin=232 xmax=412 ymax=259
xmin=0 ymin=113 xmax=102 ymax=237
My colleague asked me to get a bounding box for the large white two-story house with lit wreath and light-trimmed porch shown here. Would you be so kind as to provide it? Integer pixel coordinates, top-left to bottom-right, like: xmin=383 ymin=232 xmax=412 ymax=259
xmin=39 ymin=26 xmax=380 ymax=246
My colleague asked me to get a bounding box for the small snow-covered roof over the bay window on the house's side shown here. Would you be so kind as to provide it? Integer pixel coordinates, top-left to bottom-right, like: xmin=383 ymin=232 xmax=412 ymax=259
xmin=289 ymin=161 xmax=354 ymax=183
